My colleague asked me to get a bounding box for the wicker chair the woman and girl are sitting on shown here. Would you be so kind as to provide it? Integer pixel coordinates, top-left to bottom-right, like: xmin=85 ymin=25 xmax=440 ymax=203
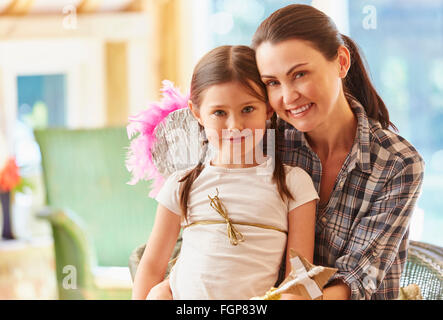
xmin=129 ymin=238 xmax=443 ymax=300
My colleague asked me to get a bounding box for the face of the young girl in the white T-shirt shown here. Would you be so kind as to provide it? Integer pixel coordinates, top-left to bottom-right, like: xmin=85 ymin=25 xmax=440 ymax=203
xmin=189 ymin=81 xmax=273 ymax=165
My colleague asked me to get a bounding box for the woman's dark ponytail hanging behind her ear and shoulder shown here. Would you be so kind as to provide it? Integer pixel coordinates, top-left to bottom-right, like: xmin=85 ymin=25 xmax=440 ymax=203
xmin=341 ymin=34 xmax=397 ymax=130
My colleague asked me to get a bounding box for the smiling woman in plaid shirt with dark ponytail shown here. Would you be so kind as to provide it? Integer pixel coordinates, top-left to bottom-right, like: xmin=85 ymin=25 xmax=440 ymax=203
xmin=252 ymin=5 xmax=424 ymax=299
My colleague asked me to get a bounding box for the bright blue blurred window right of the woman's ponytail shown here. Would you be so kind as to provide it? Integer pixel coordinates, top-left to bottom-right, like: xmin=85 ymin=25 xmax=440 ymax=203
xmin=348 ymin=0 xmax=443 ymax=246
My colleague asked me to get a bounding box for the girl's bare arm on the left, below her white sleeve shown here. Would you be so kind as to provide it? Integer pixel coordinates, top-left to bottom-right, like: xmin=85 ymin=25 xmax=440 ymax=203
xmin=132 ymin=204 xmax=181 ymax=300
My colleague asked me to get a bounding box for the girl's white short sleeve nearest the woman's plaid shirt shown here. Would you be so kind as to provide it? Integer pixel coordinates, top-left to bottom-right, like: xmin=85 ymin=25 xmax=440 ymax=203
xmin=286 ymin=167 xmax=319 ymax=212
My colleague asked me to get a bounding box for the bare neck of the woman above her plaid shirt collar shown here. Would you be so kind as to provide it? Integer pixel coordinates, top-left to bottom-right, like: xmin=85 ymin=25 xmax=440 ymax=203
xmin=306 ymin=91 xmax=357 ymax=159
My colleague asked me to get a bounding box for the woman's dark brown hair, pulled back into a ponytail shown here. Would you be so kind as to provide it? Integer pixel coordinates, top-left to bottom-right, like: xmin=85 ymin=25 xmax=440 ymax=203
xmin=252 ymin=4 xmax=397 ymax=130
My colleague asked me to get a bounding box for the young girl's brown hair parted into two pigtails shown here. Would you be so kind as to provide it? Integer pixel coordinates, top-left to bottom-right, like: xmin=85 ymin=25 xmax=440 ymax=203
xmin=179 ymin=46 xmax=293 ymax=219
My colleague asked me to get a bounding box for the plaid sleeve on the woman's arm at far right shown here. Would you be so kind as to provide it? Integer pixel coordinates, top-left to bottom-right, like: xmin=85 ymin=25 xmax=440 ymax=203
xmin=330 ymin=159 xmax=424 ymax=300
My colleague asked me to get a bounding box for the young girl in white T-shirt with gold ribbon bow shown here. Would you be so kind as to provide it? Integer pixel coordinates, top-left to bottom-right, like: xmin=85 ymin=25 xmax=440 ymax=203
xmin=133 ymin=46 xmax=318 ymax=299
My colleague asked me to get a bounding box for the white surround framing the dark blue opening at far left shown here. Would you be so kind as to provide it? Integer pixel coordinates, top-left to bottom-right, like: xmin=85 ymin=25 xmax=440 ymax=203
xmin=0 ymin=38 xmax=105 ymax=130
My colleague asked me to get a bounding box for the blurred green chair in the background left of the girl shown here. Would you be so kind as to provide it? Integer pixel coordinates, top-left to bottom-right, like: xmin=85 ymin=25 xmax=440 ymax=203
xmin=35 ymin=127 xmax=157 ymax=299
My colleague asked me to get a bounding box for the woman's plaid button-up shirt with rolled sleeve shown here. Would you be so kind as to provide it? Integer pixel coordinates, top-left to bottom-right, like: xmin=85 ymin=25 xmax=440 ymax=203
xmin=278 ymin=100 xmax=424 ymax=299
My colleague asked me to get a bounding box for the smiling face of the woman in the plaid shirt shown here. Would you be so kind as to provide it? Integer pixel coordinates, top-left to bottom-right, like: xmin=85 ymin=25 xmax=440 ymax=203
xmin=256 ymin=39 xmax=349 ymax=132
